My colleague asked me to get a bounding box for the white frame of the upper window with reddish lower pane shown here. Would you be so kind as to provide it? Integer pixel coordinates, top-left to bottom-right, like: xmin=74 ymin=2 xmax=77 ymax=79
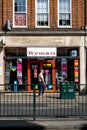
xmin=13 ymin=0 xmax=27 ymax=28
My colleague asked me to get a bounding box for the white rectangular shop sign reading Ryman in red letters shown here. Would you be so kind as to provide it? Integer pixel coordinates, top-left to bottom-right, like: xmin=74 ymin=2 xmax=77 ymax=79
xmin=27 ymin=47 xmax=57 ymax=57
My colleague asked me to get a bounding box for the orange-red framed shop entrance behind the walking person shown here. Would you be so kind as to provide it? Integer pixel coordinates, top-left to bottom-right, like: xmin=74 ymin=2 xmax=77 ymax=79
xmin=28 ymin=59 xmax=56 ymax=92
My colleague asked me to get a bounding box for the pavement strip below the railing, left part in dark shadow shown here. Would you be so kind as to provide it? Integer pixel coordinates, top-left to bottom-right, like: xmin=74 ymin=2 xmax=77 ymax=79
xmin=0 ymin=117 xmax=87 ymax=130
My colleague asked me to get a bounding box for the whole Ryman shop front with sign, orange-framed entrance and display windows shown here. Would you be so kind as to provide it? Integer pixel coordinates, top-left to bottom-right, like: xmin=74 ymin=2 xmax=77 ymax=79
xmin=5 ymin=47 xmax=80 ymax=92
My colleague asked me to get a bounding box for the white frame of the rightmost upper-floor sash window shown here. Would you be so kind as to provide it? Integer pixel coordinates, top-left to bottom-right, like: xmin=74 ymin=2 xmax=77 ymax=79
xmin=58 ymin=0 xmax=72 ymax=28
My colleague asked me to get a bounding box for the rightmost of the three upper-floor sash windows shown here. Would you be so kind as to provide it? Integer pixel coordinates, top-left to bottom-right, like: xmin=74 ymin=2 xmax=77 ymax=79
xmin=58 ymin=0 xmax=72 ymax=27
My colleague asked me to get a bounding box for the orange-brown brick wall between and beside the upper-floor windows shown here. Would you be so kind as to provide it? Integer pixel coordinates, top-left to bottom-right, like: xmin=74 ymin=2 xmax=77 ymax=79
xmin=0 ymin=0 xmax=87 ymax=30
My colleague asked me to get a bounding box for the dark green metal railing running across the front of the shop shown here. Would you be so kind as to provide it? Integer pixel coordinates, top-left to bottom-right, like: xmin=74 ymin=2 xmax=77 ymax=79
xmin=0 ymin=84 xmax=87 ymax=120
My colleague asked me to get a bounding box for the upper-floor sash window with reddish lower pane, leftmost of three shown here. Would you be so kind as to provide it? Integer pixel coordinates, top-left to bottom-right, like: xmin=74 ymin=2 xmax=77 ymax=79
xmin=13 ymin=0 xmax=27 ymax=27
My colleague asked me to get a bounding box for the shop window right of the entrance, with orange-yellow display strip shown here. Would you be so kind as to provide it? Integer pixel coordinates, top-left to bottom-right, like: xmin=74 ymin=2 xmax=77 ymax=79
xmin=56 ymin=48 xmax=80 ymax=88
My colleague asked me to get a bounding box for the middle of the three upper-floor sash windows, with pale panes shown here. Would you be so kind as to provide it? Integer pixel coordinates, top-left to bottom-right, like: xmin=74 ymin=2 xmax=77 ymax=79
xmin=36 ymin=0 xmax=49 ymax=27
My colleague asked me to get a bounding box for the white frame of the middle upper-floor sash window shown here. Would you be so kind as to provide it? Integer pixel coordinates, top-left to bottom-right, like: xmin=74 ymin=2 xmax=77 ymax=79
xmin=35 ymin=0 xmax=50 ymax=28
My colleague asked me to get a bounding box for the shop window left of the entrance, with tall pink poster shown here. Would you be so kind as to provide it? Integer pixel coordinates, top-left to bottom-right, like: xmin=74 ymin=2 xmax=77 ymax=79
xmin=5 ymin=58 xmax=27 ymax=91
